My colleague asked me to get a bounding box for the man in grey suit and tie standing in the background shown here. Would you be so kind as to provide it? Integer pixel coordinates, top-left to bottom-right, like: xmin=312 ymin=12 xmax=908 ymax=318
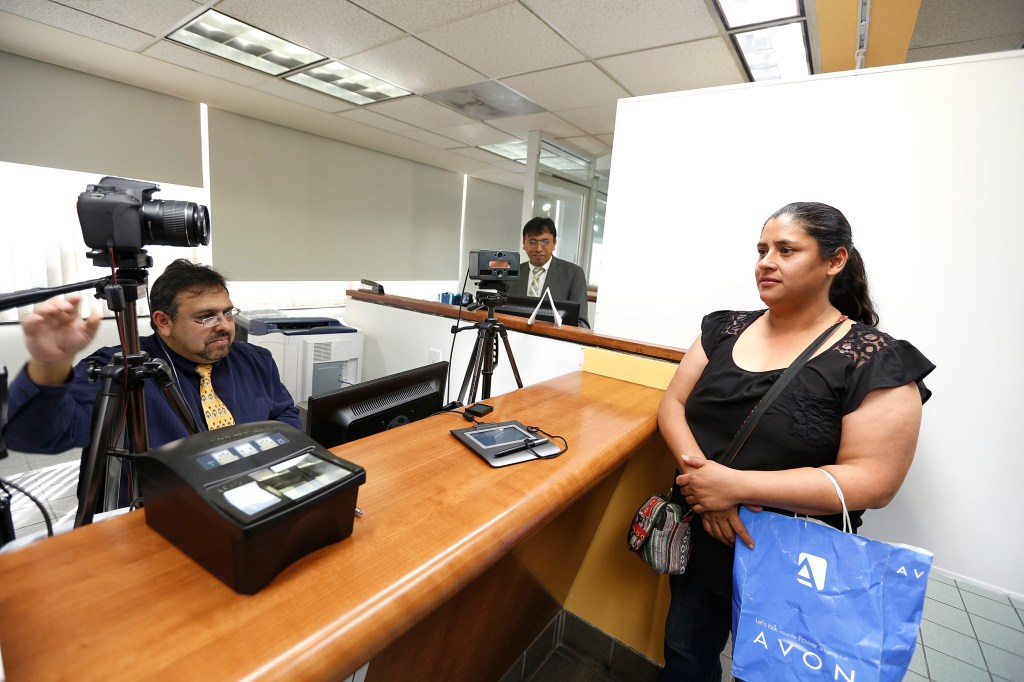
xmin=509 ymin=217 xmax=590 ymax=327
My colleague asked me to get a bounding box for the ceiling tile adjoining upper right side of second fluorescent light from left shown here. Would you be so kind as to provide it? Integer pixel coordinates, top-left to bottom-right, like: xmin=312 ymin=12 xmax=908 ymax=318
xmin=345 ymin=36 xmax=484 ymax=94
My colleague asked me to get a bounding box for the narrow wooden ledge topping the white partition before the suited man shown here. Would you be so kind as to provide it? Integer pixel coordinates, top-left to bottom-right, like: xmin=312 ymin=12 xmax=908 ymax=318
xmin=346 ymin=290 xmax=684 ymax=363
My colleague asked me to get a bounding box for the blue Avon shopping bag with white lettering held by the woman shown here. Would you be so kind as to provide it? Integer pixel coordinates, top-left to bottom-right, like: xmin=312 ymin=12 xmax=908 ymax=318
xmin=732 ymin=502 xmax=932 ymax=682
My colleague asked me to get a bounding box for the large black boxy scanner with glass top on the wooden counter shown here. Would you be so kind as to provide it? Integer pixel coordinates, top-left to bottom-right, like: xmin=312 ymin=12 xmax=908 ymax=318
xmin=137 ymin=421 xmax=367 ymax=594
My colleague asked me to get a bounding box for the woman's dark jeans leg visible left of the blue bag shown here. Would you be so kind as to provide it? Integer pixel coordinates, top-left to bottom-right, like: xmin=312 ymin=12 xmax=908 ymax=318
xmin=660 ymin=576 xmax=732 ymax=682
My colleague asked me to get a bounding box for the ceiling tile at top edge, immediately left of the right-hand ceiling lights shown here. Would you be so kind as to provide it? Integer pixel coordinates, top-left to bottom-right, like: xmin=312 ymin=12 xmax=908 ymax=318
xmin=529 ymin=0 xmax=718 ymax=57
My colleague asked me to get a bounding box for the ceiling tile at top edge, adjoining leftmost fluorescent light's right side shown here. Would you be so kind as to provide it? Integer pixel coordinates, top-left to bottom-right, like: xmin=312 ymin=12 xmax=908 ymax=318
xmin=216 ymin=0 xmax=404 ymax=59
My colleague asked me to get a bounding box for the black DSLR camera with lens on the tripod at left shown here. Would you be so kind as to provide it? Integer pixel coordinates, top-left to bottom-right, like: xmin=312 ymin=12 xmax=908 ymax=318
xmin=78 ymin=177 xmax=210 ymax=252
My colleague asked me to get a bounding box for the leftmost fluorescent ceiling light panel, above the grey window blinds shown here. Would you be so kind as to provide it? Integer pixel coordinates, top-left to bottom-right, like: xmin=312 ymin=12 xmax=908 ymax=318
xmin=168 ymin=9 xmax=326 ymax=76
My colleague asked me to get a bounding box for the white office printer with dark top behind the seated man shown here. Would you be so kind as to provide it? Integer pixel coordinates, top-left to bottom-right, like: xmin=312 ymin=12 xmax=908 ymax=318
xmin=236 ymin=310 xmax=362 ymax=403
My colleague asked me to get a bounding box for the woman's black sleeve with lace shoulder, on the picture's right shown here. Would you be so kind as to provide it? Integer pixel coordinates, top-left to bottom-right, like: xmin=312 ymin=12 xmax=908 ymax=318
xmin=837 ymin=325 xmax=935 ymax=415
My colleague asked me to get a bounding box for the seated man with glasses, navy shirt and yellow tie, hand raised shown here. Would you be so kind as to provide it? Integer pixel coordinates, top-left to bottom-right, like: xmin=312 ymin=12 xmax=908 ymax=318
xmin=4 ymin=258 xmax=301 ymax=462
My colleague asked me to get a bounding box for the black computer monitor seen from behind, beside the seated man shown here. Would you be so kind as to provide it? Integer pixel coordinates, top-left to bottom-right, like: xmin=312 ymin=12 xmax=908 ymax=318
xmin=306 ymin=361 xmax=449 ymax=447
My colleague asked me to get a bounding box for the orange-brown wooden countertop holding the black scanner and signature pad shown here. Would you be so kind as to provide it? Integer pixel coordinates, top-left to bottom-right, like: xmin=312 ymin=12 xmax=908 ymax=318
xmin=0 ymin=373 xmax=662 ymax=682
